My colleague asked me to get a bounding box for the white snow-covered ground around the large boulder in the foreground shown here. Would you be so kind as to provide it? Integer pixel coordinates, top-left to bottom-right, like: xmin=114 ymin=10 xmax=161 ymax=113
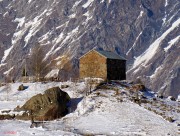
xmin=0 ymin=82 xmax=180 ymax=136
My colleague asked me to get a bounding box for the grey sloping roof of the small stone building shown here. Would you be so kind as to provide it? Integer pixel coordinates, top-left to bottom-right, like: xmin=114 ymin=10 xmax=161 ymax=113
xmin=95 ymin=49 xmax=126 ymax=60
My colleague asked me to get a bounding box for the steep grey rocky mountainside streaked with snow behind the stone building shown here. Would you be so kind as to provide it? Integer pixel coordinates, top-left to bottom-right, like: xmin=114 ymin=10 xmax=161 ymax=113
xmin=0 ymin=0 xmax=180 ymax=96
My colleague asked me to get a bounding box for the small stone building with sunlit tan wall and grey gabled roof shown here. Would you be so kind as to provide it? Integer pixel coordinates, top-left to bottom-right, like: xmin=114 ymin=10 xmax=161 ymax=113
xmin=79 ymin=49 xmax=126 ymax=80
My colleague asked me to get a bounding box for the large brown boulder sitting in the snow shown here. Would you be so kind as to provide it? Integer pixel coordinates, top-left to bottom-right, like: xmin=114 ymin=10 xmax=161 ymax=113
xmin=16 ymin=87 xmax=70 ymax=120
